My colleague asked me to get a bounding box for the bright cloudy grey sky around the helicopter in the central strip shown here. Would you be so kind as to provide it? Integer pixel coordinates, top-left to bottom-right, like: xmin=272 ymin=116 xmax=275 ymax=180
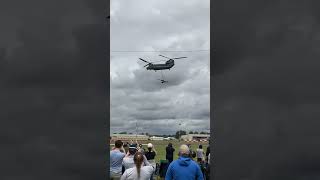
xmin=110 ymin=0 xmax=210 ymax=134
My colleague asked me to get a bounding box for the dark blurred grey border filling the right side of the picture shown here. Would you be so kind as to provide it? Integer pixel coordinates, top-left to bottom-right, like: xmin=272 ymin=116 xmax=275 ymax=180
xmin=213 ymin=0 xmax=320 ymax=180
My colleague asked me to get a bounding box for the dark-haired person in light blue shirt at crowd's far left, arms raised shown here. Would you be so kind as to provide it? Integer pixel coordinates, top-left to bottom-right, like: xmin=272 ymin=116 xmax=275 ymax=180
xmin=110 ymin=140 xmax=126 ymax=180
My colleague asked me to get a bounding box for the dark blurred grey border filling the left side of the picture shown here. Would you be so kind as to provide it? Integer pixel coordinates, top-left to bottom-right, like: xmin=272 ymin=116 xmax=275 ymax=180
xmin=0 ymin=1 xmax=108 ymax=180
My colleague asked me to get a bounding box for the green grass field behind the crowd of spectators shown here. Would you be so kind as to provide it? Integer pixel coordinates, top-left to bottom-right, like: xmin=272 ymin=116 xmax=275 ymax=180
xmin=110 ymin=140 xmax=208 ymax=163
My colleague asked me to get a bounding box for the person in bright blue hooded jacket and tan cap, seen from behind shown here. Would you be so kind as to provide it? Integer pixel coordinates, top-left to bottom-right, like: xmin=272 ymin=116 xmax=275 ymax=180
xmin=165 ymin=145 xmax=203 ymax=180
